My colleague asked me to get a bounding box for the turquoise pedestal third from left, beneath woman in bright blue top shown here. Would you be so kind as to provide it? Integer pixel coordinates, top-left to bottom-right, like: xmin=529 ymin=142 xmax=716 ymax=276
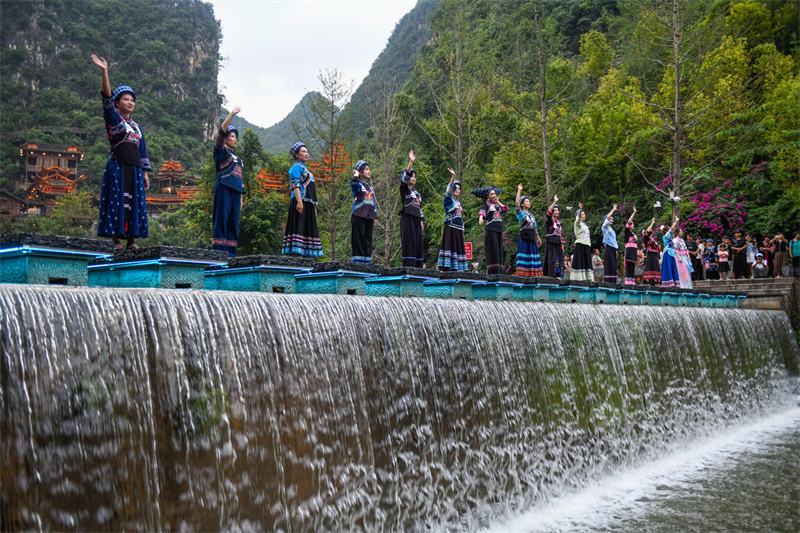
xmin=205 ymin=265 xmax=311 ymax=294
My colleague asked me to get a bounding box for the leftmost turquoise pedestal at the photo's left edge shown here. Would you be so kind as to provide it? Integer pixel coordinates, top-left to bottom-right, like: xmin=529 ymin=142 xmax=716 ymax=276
xmin=0 ymin=244 xmax=110 ymax=287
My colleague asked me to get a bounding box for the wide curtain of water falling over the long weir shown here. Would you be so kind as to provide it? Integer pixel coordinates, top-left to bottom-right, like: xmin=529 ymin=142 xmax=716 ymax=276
xmin=0 ymin=285 xmax=800 ymax=531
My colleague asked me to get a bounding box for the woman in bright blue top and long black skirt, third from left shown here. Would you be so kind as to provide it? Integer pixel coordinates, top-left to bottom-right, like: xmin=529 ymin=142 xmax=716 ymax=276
xmin=281 ymin=142 xmax=322 ymax=257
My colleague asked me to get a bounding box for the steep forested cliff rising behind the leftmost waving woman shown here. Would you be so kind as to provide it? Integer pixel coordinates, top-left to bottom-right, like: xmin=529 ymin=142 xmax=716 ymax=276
xmin=0 ymin=0 xmax=221 ymax=192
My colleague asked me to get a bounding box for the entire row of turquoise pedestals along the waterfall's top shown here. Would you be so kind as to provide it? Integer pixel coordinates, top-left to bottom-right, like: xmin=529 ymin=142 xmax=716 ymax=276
xmin=0 ymin=247 xmax=739 ymax=308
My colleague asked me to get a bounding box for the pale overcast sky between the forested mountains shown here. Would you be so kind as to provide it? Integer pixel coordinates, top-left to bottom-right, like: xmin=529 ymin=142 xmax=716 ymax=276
xmin=208 ymin=0 xmax=416 ymax=128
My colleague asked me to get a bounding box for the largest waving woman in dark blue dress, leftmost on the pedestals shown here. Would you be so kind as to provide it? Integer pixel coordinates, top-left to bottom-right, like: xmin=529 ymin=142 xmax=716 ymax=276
xmin=92 ymin=54 xmax=151 ymax=250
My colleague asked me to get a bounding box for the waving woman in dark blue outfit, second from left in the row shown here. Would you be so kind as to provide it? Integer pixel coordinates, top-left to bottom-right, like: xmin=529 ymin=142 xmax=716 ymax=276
xmin=211 ymin=106 xmax=244 ymax=257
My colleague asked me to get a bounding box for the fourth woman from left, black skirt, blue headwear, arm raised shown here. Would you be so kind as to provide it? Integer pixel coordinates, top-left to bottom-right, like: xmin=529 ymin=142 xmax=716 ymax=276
xmin=350 ymin=160 xmax=378 ymax=264
